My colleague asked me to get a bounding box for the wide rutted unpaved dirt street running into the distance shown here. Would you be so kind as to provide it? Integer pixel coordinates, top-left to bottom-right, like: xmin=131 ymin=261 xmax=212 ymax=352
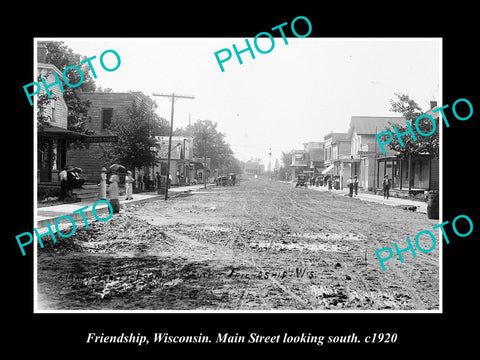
xmin=37 ymin=179 xmax=439 ymax=310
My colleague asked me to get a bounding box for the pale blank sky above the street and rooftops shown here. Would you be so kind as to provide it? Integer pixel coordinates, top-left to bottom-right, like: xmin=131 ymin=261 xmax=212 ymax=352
xmin=42 ymin=37 xmax=442 ymax=166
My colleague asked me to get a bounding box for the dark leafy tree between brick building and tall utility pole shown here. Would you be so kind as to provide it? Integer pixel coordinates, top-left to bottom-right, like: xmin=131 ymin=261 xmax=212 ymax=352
xmin=102 ymin=101 xmax=156 ymax=172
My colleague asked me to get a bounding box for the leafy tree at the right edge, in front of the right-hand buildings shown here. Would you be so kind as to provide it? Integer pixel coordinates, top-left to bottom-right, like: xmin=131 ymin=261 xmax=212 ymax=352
xmin=383 ymin=93 xmax=440 ymax=158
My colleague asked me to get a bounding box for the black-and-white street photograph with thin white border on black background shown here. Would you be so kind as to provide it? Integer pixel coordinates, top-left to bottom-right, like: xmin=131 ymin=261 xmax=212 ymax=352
xmin=31 ymin=37 xmax=440 ymax=313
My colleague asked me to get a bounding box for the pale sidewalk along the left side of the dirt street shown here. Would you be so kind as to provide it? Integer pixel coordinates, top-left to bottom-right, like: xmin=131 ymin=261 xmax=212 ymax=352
xmin=36 ymin=184 xmax=214 ymax=229
